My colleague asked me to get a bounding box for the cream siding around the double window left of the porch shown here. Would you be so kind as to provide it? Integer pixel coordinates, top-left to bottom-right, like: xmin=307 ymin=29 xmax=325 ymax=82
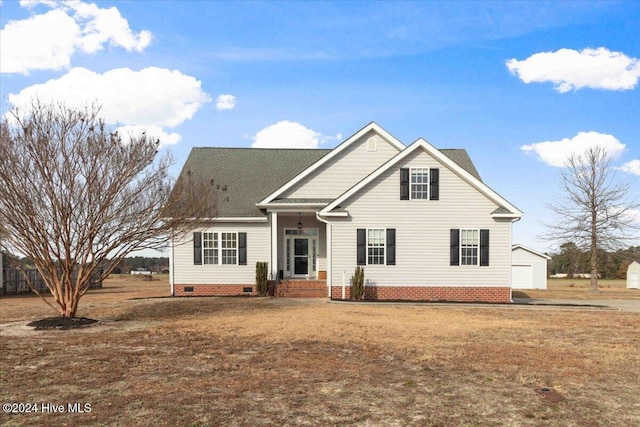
xmin=172 ymin=223 xmax=271 ymax=285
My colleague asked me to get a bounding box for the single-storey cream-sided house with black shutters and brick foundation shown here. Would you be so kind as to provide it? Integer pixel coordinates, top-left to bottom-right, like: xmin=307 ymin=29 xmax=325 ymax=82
xmin=170 ymin=123 xmax=522 ymax=302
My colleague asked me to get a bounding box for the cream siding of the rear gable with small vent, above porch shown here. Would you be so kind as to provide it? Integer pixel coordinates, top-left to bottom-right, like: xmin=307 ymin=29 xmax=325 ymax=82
xmin=281 ymin=131 xmax=399 ymax=199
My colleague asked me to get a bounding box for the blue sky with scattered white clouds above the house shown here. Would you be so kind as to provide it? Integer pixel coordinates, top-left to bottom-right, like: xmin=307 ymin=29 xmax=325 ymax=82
xmin=0 ymin=0 xmax=640 ymax=251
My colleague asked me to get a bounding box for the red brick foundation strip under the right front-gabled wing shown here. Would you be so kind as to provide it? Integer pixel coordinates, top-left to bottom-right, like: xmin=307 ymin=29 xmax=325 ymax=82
xmin=331 ymin=286 xmax=511 ymax=303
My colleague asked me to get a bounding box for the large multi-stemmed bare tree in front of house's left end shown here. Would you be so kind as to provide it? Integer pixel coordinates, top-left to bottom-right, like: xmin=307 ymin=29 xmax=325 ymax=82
xmin=0 ymin=100 xmax=215 ymax=317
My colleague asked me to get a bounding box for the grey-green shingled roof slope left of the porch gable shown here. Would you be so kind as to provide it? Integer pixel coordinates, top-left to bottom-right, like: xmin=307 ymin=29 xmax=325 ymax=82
xmin=178 ymin=147 xmax=331 ymax=218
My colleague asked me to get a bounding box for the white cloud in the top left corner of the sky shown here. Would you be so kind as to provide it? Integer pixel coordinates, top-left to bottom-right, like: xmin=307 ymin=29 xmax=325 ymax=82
xmin=0 ymin=1 xmax=152 ymax=74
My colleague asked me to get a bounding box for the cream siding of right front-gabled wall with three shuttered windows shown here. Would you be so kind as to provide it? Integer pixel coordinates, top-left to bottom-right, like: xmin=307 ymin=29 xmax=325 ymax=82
xmin=332 ymin=150 xmax=511 ymax=287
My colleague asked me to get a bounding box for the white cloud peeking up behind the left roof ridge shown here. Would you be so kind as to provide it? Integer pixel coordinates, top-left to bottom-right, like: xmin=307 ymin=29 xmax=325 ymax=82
xmin=251 ymin=120 xmax=322 ymax=148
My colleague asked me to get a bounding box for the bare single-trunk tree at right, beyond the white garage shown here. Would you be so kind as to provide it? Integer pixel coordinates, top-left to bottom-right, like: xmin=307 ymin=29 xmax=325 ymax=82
xmin=545 ymin=146 xmax=638 ymax=293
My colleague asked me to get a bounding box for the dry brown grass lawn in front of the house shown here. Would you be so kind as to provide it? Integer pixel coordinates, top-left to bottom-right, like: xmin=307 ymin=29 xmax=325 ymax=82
xmin=0 ymin=279 xmax=640 ymax=426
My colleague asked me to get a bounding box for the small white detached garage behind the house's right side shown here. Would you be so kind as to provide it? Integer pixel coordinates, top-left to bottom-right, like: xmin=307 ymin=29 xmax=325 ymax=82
xmin=511 ymin=245 xmax=551 ymax=289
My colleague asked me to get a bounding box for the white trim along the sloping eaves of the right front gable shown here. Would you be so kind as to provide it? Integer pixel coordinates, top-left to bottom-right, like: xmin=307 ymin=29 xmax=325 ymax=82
xmin=319 ymin=138 xmax=523 ymax=218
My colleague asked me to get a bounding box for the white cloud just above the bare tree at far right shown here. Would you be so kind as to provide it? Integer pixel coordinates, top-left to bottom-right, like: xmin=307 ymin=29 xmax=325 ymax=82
xmin=520 ymin=132 xmax=625 ymax=167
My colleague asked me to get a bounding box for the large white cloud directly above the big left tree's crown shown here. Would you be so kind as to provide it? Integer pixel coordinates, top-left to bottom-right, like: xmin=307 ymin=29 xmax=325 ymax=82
xmin=9 ymin=67 xmax=211 ymax=144
